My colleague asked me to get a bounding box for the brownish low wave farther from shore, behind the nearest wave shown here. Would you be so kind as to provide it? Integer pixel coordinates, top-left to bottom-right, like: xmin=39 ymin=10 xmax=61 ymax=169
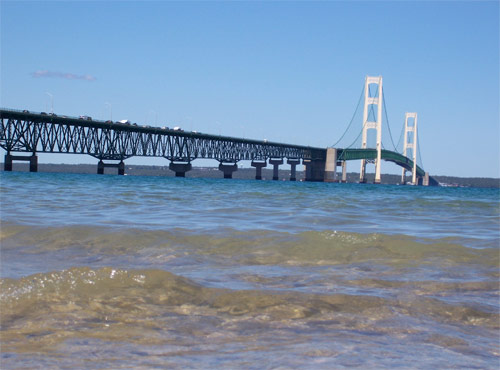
xmin=0 ymin=224 xmax=500 ymax=267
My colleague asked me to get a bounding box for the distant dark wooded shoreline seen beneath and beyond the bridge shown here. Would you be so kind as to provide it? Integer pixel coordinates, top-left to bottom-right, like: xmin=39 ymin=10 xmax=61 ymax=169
xmin=0 ymin=163 xmax=500 ymax=188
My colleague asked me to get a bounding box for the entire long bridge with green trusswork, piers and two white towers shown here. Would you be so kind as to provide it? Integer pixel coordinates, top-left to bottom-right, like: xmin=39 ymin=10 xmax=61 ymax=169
xmin=0 ymin=77 xmax=437 ymax=185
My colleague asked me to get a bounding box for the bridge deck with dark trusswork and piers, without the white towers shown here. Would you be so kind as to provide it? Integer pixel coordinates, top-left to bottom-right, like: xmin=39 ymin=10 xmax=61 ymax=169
xmin=0 ymin=109 xmax=434 ymax=181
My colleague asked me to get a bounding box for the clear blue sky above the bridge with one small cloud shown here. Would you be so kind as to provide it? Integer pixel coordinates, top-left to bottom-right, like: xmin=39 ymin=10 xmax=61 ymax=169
xmin=0 ymin=1 xmax=500 ymax=177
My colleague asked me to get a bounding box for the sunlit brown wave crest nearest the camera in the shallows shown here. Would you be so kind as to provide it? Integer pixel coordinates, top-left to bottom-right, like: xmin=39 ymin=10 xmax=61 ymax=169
xmin=0 ymin=267 xmax=499 ymax=327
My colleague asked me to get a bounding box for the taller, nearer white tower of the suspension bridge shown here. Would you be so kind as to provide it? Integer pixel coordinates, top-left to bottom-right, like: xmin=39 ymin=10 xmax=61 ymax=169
xmin=359 ymin=76 xmax=382 ymax=184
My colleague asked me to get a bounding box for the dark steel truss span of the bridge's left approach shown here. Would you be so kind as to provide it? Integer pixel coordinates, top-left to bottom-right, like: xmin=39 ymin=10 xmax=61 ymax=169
xmin=0 ymin=109 xmax=326 ymax=163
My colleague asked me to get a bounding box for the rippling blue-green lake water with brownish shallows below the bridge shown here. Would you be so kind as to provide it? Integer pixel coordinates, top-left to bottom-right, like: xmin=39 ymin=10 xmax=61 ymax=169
xmin=0 ymin=172 xmax=500 ymax=369
